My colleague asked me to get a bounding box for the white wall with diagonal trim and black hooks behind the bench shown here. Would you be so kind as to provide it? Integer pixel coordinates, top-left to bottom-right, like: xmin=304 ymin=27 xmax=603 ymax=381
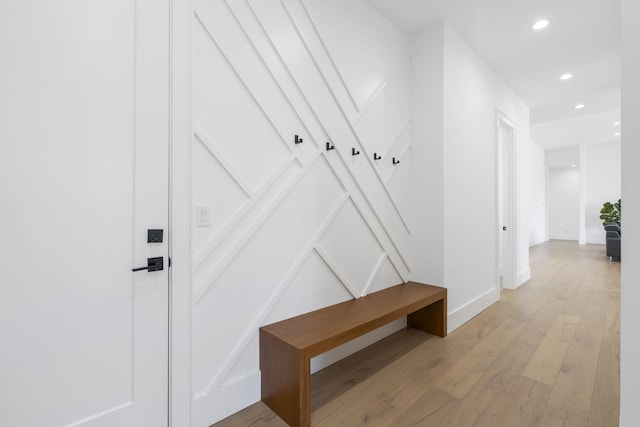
xmin=191 ymin=0 xmax=412 ymax=426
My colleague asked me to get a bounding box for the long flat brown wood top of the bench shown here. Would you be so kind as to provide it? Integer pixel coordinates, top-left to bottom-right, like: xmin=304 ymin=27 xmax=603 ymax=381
xmin=260 ymin=282 xmax=447 ymax=357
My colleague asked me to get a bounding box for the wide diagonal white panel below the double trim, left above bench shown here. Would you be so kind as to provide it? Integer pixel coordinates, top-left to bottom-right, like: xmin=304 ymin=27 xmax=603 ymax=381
xmin=192 ymin=160 xmax=343 ymax=392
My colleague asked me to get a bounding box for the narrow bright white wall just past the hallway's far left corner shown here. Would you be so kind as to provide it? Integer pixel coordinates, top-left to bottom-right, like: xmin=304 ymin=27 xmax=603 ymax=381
xmin=529 ymin=140 xmax=549 ymax=246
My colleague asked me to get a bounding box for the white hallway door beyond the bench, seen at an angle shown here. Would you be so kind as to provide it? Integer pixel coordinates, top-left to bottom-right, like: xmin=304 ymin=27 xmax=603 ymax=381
xmin=497 ymin=114 xmax=516 ymax=289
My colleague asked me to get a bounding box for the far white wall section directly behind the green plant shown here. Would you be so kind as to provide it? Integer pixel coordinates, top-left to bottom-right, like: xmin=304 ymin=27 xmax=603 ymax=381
xmin=584 ymin=142 xmax=622 ymax=244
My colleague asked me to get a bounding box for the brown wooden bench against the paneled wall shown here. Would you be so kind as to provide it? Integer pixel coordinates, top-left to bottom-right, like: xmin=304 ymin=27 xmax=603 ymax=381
xmin=260 ymin=282 xmax=447 ymax=427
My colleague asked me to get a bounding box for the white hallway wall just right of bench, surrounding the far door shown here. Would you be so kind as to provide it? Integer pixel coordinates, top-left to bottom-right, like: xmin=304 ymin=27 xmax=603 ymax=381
xmin=412 ymin=23 xmax=529 ymax=330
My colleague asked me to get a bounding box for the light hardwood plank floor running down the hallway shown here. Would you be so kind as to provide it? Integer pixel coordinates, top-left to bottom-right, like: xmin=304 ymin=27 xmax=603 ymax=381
xmin=215 ymin=241 xmax=620 ymax=427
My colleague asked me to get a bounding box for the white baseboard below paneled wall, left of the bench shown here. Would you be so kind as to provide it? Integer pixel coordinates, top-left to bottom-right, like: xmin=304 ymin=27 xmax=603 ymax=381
xmin=191 ymin=371 xmax=260 ymax=427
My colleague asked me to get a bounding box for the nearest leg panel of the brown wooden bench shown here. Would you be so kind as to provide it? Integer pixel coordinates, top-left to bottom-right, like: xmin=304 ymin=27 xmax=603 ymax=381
xmin=260 ymin=330 xmax=311 ymax=427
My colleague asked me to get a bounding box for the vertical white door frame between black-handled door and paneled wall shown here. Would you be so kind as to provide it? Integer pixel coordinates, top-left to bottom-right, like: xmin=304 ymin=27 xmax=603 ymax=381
xmin=169 ymin=0 xmax=193 ymax=426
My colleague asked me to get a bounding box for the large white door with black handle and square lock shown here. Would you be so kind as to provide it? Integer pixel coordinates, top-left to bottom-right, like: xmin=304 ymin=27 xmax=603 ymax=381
xmin=0 ymin=0 xmax=169 ymax=427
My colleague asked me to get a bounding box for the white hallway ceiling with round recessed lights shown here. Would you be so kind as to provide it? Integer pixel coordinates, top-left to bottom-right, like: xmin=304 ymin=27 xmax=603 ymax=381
xmin=367 ymin=0 xmax=620 ymax=146
